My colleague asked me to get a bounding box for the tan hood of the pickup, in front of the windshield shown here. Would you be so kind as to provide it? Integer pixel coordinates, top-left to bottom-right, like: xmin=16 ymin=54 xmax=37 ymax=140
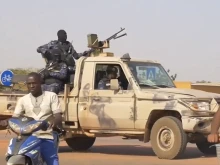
xmin=143 ymin=88 xmax=220 ymax=99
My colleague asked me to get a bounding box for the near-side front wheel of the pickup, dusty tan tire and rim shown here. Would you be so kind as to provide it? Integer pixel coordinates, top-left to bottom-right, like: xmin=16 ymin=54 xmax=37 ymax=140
xmin=150 ymin=116 xmax=188 ymax=160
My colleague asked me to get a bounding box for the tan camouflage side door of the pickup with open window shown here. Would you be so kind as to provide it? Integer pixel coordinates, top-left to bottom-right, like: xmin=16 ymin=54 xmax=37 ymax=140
xmin=79 ymin=63 xmax=134 ymax=130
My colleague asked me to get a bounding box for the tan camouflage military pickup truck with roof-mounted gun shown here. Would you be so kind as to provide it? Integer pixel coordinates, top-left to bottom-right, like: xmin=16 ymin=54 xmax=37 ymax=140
xmin=0 ymin=29 xmax=220 ymax=159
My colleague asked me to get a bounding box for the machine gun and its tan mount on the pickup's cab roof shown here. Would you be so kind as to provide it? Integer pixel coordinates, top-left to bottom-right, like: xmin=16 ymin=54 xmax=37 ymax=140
xmin=87 ymin=28 xmax=127 ymax=56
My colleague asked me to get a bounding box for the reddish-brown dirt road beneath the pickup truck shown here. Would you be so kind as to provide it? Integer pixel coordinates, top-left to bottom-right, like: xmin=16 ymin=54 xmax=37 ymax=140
xmin=0 ymin=131 xmax=219 ymax=165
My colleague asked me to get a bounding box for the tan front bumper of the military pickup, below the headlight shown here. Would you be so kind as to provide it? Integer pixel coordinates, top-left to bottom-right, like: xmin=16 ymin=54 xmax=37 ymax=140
xmin=182 ymin=116 xmax=213 ymax=134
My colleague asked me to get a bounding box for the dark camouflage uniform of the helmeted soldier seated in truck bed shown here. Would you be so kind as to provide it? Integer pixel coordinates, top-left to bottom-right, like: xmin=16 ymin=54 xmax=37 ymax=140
xmin=42 ymin=62 xmax=68 ymax=94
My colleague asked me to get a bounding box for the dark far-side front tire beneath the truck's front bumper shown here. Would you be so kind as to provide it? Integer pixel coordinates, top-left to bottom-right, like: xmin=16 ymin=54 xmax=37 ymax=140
xmin=196 ymin=140 xmax=216 ymax=155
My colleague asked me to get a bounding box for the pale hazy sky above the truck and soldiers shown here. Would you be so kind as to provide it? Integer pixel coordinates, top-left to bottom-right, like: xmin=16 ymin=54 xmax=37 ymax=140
xmin=0 ymin=0 xmax=220 ymax=82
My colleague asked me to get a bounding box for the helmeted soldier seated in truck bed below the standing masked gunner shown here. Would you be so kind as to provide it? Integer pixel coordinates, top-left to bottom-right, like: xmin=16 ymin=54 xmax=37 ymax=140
xmin=41 ymin=48 xmax=68 ymax=94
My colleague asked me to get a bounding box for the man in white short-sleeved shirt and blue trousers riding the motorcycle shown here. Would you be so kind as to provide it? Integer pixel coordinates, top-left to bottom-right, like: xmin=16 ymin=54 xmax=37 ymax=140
xmin=3 ymin=72 xmax=62 ymax=165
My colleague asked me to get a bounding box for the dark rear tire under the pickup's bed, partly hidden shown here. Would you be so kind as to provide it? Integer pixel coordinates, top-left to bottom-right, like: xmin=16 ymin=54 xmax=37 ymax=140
xmin=66 ymin=137 xmax=96 ymax=151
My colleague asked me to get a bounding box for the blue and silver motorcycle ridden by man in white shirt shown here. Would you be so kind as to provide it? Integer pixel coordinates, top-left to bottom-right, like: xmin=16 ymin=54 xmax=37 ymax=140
xmin=6 ymin=116 xmax=65 ymax=165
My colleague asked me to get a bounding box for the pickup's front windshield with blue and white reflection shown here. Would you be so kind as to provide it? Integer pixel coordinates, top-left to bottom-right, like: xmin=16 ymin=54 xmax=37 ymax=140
xmin=128 ymin=61 xmax=175 ymax=88
